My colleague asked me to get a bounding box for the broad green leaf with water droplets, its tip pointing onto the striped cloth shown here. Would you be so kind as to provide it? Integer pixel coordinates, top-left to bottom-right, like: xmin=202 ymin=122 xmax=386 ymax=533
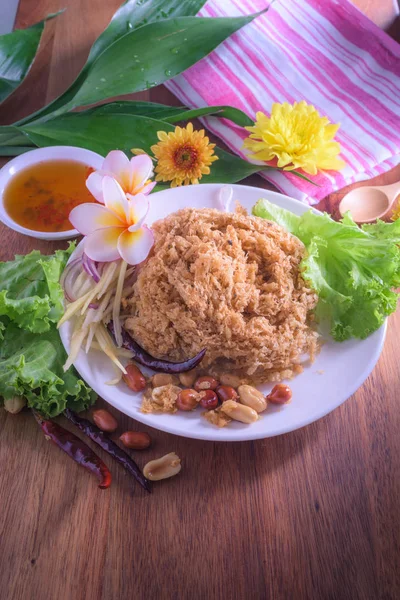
xmin=53 ymin=15 xmax=257 ymax=115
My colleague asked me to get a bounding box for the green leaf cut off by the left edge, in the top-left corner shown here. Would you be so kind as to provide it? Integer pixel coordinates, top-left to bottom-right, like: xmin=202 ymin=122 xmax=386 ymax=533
xmin=0 ymin=13 xmax=58 ymax=102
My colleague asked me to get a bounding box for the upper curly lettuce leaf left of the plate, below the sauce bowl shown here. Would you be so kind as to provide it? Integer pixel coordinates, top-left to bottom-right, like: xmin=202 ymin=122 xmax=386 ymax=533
xmin=0 ymin=245 xmax=74 ymax=333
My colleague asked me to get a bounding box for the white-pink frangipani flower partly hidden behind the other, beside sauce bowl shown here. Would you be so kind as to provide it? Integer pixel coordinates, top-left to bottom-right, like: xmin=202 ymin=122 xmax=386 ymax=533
xmin=86 ymin=150 xmax=156 ymax=204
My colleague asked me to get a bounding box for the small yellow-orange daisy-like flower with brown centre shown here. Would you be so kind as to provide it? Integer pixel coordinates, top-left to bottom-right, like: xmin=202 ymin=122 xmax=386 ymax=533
xmin=151 ymin=123 xmax=218 ymax=187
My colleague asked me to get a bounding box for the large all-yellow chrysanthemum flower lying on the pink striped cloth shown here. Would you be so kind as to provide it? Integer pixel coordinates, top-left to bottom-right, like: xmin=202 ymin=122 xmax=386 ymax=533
xmin=244 ymin=100 xmax=345 ymax=175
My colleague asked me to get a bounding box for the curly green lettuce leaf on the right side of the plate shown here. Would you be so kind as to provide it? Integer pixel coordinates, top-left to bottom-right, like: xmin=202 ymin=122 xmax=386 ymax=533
xmin=253 ymin=200 xmax=400 ymax=341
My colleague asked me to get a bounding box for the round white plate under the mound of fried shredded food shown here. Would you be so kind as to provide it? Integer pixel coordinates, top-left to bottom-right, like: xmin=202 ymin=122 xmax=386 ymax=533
xmin=60 ymin=184 xmax=386 ymax=442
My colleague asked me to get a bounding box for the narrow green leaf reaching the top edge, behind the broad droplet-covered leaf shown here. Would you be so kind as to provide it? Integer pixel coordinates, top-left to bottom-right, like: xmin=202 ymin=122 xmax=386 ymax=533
xmin=18 ymin=0 xmax=205 ymax=125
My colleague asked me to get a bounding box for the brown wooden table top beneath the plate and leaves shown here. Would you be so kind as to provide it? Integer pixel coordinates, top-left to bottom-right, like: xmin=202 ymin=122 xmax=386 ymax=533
xmin=0 ymin=0 xmax=400 ymax=600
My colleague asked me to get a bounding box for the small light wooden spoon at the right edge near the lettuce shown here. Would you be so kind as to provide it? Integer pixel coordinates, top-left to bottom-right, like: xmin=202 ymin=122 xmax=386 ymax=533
xmin=339 ymin=181 xmax=400 ymax=223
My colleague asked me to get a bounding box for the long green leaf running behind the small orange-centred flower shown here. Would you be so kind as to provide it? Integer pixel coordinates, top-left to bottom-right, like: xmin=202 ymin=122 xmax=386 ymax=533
xmin=22 ymin=113 xmax=272 ymax=183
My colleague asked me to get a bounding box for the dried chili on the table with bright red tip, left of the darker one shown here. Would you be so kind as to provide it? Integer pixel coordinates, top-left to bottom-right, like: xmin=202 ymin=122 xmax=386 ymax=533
xmin=32 ymin=410 xmax=111 ymax=489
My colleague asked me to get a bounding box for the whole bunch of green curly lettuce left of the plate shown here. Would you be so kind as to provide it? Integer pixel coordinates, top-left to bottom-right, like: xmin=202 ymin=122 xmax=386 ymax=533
xmin=0 ymin=244 xmax=96 ymax=417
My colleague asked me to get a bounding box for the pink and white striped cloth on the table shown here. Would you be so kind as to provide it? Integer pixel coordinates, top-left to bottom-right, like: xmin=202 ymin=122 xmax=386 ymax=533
xmin=167 ymin=0 xmax=400 ymax=204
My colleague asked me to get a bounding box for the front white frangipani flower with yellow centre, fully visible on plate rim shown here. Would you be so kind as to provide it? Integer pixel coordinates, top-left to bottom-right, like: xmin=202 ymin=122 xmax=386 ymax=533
xmin=69 ymin=175 xmax=153 ymax=265
